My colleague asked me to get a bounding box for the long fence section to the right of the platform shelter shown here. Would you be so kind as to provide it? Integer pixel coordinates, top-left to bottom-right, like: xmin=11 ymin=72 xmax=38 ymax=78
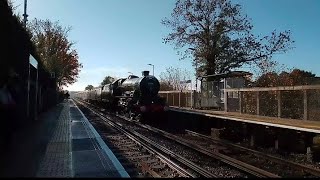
xmin=224 ymin=85 xmax=320 ymax=120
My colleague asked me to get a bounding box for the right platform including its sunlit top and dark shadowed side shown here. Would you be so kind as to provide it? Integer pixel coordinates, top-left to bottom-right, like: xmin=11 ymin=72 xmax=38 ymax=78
xmin=169 ymin=106 xmax=320 ymax=158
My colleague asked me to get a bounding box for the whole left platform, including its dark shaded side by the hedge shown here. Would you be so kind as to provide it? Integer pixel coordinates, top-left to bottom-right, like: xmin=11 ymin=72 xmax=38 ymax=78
xmin=0 ymin=100 xmax=129 ymax=178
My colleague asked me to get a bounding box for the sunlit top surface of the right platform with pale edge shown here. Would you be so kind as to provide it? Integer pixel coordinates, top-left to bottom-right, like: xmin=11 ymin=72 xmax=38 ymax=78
xmin=170 ymin=106 xmax=320 ymax=133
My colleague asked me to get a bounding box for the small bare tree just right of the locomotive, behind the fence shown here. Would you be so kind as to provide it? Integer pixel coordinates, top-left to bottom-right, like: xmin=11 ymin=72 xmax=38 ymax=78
xmin=160 ymin=67 xmax=191 ymax=91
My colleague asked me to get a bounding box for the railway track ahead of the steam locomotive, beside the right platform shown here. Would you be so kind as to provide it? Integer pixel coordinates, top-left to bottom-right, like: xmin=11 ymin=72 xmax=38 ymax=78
xmin=75 ymin=99 xmax=320 ymax=178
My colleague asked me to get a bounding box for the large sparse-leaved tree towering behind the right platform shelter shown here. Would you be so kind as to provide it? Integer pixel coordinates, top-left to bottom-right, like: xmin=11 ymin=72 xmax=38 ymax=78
xmin=162 ymin=0 xmax=294 ymax=75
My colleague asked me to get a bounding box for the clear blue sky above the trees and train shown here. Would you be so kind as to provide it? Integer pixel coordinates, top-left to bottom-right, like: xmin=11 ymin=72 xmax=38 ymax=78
xmin=13 ymin=0 xmax=320 ymax=91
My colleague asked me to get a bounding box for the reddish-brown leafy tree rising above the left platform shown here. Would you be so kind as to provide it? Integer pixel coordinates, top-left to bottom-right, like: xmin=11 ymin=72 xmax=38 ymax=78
xmin=29 ymin=19 xmax=82 ymax=87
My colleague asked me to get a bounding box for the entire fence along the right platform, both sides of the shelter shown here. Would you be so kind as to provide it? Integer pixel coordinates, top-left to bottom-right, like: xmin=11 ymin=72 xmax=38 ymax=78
xmin=159 ymin=85 xmax=320 ymax=121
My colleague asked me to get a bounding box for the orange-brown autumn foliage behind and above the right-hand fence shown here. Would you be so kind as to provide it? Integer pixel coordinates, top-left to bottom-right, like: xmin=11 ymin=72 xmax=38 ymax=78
xmin=242 ymin=69 xmax=320 ymax=119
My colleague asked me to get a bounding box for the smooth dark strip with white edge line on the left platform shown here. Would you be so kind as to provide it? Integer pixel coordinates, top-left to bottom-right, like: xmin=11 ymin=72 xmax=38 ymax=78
xmin=69 ymin=100 xmax=129 ymax=177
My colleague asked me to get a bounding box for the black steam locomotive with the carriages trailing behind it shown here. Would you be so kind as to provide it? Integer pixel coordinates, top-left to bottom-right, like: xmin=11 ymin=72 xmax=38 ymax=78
xmin=75 ymin=71 xmax=167 ymax=121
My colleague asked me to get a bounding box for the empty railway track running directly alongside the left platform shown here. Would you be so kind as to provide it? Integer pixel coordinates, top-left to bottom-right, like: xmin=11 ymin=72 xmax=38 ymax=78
xmin=78 ymin=102 xmax=216 ymax=178
